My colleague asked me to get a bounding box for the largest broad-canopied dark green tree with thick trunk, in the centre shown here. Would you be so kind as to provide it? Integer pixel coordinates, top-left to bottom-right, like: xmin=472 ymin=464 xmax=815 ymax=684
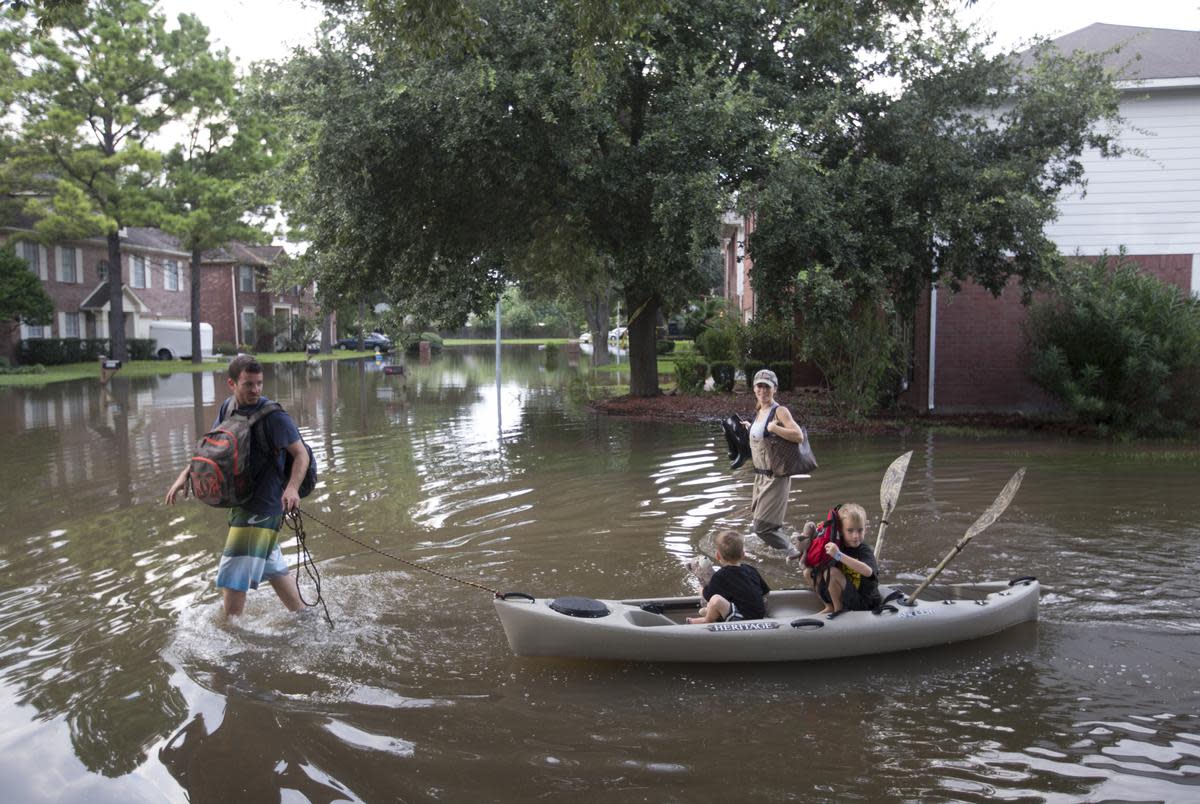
xmin=274 ymin=0 xmax=919 ymax=395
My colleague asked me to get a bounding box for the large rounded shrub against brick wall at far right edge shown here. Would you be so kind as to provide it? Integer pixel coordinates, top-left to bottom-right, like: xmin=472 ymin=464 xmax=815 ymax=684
xmin=1025 ymin=254 xmax=1200 ymax=436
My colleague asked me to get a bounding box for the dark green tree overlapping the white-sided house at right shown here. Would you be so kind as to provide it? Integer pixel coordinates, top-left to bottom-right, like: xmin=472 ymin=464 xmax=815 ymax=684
xmin=746 ymin=9 xmax=1118 ymax=374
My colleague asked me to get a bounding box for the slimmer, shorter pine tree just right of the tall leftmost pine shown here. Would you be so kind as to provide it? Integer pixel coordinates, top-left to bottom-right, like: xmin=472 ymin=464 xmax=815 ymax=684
xmin=162 ymin=63 xmax=277 ymax=362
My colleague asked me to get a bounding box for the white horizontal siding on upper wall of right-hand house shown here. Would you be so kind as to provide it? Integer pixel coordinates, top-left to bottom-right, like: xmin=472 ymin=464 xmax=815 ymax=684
xmin=1046 ymin=86 xmax=1200 ymax=256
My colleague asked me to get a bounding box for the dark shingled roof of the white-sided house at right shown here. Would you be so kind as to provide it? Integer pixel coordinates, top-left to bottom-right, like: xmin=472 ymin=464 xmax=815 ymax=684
xmin=1021 ymin=23 xmax=1200 ymax=82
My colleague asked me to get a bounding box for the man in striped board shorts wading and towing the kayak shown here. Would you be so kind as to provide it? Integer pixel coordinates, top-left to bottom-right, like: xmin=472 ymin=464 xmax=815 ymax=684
xmin=166 ymin=355 xmax=308 ymax=617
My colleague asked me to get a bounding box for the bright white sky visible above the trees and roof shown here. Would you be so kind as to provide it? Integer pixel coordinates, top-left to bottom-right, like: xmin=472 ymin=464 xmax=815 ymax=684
xmin=158 ymin=0 xmax=1200 ymax=67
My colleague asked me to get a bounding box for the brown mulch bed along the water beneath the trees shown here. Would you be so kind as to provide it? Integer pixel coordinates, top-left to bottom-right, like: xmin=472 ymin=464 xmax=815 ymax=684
xmin=592 ymin=388 xmax=1078 ymax=434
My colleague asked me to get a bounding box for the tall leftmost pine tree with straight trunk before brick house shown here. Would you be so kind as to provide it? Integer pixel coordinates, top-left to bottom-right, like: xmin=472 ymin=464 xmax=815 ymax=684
xmin=10 ymin=0 xmax=228 ymax=359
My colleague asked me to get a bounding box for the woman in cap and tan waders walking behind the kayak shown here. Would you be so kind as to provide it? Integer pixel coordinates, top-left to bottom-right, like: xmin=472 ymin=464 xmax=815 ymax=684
xmin=750 ymin=368 xmax=804 ymax=550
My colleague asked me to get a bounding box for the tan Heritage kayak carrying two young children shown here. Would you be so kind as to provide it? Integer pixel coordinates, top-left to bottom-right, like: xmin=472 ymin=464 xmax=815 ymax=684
xmin=496 ymin=577 xmax=1040 ymax=662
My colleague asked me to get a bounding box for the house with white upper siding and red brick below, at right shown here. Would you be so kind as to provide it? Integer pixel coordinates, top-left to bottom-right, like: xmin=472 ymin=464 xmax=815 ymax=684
xmin=902 ymin=24 xmax=1200 ymax=413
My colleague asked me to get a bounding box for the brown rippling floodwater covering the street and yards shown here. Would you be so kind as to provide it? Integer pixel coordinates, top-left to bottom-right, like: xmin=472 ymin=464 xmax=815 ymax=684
xmin=0 ymin=347 xmax=1200 ymax=803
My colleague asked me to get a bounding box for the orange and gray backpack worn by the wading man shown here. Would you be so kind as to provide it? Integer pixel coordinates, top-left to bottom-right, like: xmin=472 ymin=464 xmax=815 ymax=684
xmin=188 ymin=398 xmax=317 ymax=508
